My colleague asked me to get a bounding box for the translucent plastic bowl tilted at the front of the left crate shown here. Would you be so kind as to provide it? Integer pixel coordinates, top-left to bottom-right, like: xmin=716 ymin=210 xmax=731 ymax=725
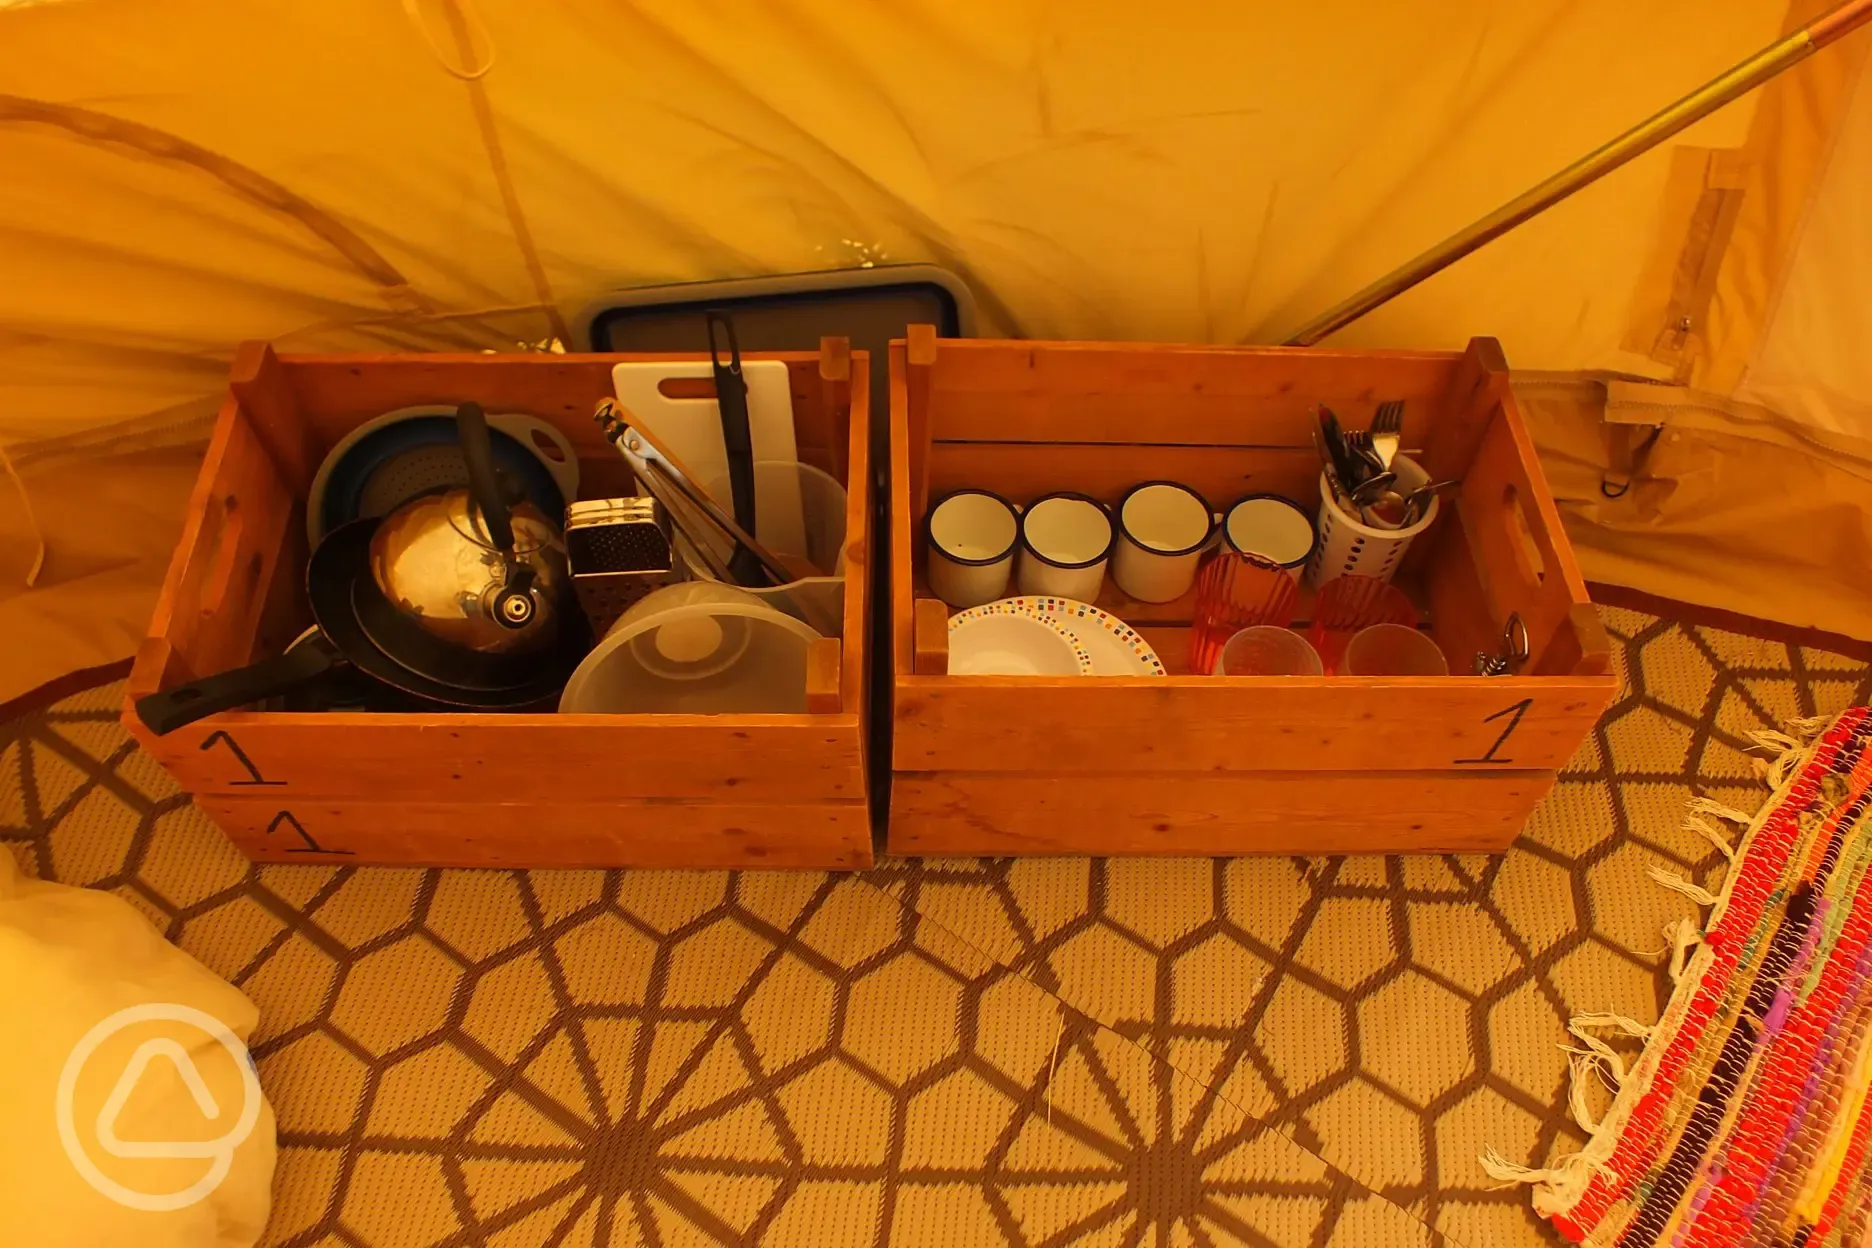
xmin=560 ymin=582 xmax=818 ymax=715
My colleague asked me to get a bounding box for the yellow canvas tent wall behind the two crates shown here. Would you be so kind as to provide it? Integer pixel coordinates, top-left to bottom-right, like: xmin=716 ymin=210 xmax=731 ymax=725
xmin=0 ymin=0 xmax=1872 ymax=698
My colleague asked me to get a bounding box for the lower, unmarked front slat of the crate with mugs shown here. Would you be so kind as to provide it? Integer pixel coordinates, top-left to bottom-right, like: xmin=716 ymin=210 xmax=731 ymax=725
xmin=885 ymin=771 xmax=1554 ymax=857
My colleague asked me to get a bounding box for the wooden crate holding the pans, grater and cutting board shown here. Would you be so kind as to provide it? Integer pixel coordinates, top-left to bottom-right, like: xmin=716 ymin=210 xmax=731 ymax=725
xmin=124 ymin=339 xmax=872 ymax=868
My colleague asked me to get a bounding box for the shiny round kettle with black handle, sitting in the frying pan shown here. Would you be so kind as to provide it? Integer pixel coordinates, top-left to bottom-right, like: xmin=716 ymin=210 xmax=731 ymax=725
xmin=371 ymin=402 xmax=571 ymax=655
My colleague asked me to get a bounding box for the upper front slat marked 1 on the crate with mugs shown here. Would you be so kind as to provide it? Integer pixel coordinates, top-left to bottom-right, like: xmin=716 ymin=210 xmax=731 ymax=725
xmin=893 ymin=675 xmax=1614 ymax=773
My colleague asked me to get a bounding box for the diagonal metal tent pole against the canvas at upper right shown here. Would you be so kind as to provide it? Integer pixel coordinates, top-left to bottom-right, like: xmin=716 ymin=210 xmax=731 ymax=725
xmin=1286 ymin=0 xmax=1872 ymax=346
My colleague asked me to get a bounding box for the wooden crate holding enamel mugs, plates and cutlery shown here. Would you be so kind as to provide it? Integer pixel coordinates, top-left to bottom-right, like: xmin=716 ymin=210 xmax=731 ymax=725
xmin=887 ymin=326 xmax=1616 ymax=855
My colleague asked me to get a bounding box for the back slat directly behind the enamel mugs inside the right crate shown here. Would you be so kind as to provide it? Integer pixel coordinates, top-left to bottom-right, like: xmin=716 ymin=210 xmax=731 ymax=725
xmin=929 ymin=442 xmax=1320 ymax=511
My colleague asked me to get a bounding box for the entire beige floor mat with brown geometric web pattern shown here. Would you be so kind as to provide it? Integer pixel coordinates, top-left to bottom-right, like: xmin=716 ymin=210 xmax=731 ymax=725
xmin=0 ymin=608 xmax=1872 ymax=1248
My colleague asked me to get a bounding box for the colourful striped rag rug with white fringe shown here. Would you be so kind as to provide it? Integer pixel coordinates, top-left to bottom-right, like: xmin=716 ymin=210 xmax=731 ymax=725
xmin=1484 ymin=707 xmax=1872 ymax=1248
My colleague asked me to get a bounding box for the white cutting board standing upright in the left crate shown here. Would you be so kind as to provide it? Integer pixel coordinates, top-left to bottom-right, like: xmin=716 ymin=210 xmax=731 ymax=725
xmin=610 ymin=359 xmax=805 ymax=554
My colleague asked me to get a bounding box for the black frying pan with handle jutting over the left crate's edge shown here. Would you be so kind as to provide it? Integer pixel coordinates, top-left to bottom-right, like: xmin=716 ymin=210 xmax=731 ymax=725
xmin=137 ymin=518 xmax=586 ymax=735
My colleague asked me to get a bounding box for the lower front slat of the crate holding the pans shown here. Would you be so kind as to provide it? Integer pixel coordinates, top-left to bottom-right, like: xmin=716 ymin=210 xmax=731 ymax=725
xmin=197 ymin=793 xmax=872 ymax=870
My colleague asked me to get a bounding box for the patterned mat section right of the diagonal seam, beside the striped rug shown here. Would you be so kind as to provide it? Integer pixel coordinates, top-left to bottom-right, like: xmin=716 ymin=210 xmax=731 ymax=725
xmin=870 ymin=610 xmax=1872 ymax=1248
